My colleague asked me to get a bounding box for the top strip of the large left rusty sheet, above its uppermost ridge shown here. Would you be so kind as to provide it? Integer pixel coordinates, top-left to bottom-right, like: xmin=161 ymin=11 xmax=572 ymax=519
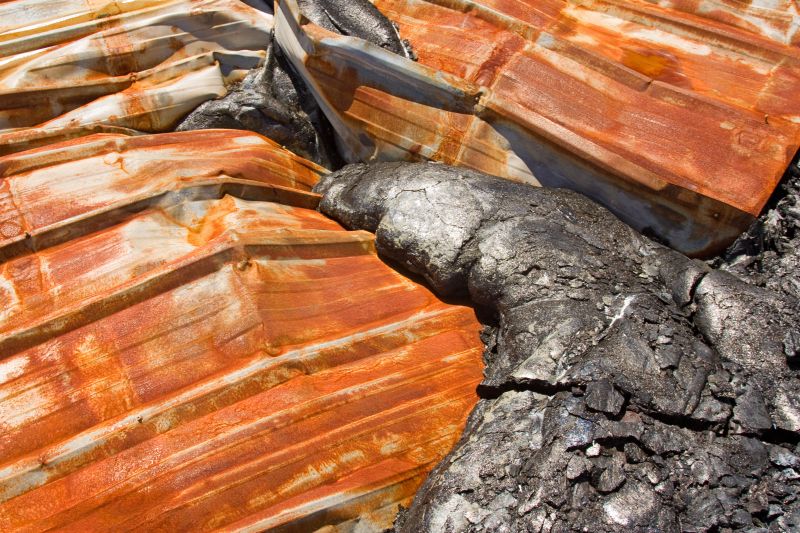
xmin=0 ymin=130 xmax=326 ymax=258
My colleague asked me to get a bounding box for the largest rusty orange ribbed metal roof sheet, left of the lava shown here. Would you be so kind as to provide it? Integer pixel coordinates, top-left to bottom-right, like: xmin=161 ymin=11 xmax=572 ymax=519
xmin=0 ymin=130 xmax=482 ymax=531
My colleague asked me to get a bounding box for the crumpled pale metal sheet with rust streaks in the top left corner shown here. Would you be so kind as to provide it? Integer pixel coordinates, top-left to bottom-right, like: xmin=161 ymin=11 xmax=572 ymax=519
xmin=0 ymin=0 xmax=272 ymax=153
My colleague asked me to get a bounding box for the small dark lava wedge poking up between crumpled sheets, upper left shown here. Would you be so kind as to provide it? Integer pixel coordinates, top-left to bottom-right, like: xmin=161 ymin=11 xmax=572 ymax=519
xmin=176 ymin=43 xmax=341 ymax=168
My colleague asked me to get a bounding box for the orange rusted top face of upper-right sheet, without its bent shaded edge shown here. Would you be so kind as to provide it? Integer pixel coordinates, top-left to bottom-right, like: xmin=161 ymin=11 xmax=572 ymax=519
xmin=362 ymin=0 xmax=800 ymax=214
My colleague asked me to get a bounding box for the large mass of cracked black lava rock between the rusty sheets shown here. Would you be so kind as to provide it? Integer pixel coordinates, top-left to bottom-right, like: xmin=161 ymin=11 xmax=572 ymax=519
xmin=317 ymin=163 xmax=800 ymax=532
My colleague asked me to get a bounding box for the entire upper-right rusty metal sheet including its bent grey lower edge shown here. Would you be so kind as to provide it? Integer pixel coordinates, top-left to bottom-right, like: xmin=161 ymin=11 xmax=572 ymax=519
xmin=275 ymin=0 xmax=800 ymax=255
